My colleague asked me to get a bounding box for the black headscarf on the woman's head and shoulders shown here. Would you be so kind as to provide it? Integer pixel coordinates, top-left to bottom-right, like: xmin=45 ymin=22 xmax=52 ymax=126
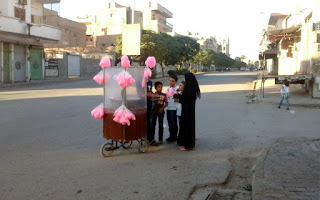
xmin=182 ymin=73 xmax=201 ymax=100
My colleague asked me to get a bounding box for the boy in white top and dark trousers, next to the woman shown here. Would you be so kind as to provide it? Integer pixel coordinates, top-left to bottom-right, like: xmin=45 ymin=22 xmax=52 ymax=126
xmin=166 ymin=75 xmax=178 ymax=143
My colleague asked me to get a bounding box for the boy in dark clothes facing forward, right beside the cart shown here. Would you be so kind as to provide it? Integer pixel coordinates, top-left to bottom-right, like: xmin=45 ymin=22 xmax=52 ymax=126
xmin=149 ymin=82 xmax=168 ymax=146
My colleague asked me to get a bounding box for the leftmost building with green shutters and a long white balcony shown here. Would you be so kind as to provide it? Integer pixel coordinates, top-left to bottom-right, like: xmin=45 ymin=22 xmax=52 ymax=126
xmin=0 ymin=0 xmax=61 ymax=83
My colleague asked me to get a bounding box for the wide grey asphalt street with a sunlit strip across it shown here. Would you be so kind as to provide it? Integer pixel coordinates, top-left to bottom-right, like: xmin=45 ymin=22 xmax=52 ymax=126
xmin=0 ymin=72 xmax=320 ymax=200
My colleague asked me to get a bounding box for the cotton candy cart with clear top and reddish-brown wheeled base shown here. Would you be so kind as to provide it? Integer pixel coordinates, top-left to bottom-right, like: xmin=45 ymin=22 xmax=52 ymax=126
xmin=94 ymin=55 xmax=156 ymax=157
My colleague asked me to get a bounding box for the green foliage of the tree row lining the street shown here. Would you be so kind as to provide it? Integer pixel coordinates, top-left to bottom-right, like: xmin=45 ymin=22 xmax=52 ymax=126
xmin=115 ymin=30 xmax=246 ymax=67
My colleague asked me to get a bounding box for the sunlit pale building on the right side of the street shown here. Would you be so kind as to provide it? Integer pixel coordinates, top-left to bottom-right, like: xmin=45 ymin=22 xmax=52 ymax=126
xmin=260 ymin=0 xmax=320 ymax=98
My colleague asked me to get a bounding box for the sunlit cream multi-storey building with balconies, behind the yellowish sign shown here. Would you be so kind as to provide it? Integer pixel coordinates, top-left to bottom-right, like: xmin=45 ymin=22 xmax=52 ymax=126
xmin=77 ymin=1 xmax=173 ymax=48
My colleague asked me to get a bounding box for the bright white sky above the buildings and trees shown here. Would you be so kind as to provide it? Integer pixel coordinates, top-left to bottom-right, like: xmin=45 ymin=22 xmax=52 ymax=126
xmin=60 ymin=0 xmax=298 ymax=60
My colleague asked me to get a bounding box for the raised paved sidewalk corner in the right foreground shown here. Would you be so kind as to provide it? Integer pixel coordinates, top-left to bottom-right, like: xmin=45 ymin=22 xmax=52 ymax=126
xmin=252 ymin=137 xmax=320 ymax=200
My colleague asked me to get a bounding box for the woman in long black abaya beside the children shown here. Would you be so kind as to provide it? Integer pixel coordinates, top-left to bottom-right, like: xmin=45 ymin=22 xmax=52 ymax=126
xmin=175 ymin=73 xmax=201 ymax=150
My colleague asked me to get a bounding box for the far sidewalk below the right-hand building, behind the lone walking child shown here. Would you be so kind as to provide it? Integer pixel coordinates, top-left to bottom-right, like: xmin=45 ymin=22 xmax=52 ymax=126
xmin=252 ymin=73 xmax=320 ymax=108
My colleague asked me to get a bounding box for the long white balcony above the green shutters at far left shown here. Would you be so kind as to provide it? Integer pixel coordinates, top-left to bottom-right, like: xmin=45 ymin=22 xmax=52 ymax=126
xmin=0 ymin=15 xmax=61 ymax=42
